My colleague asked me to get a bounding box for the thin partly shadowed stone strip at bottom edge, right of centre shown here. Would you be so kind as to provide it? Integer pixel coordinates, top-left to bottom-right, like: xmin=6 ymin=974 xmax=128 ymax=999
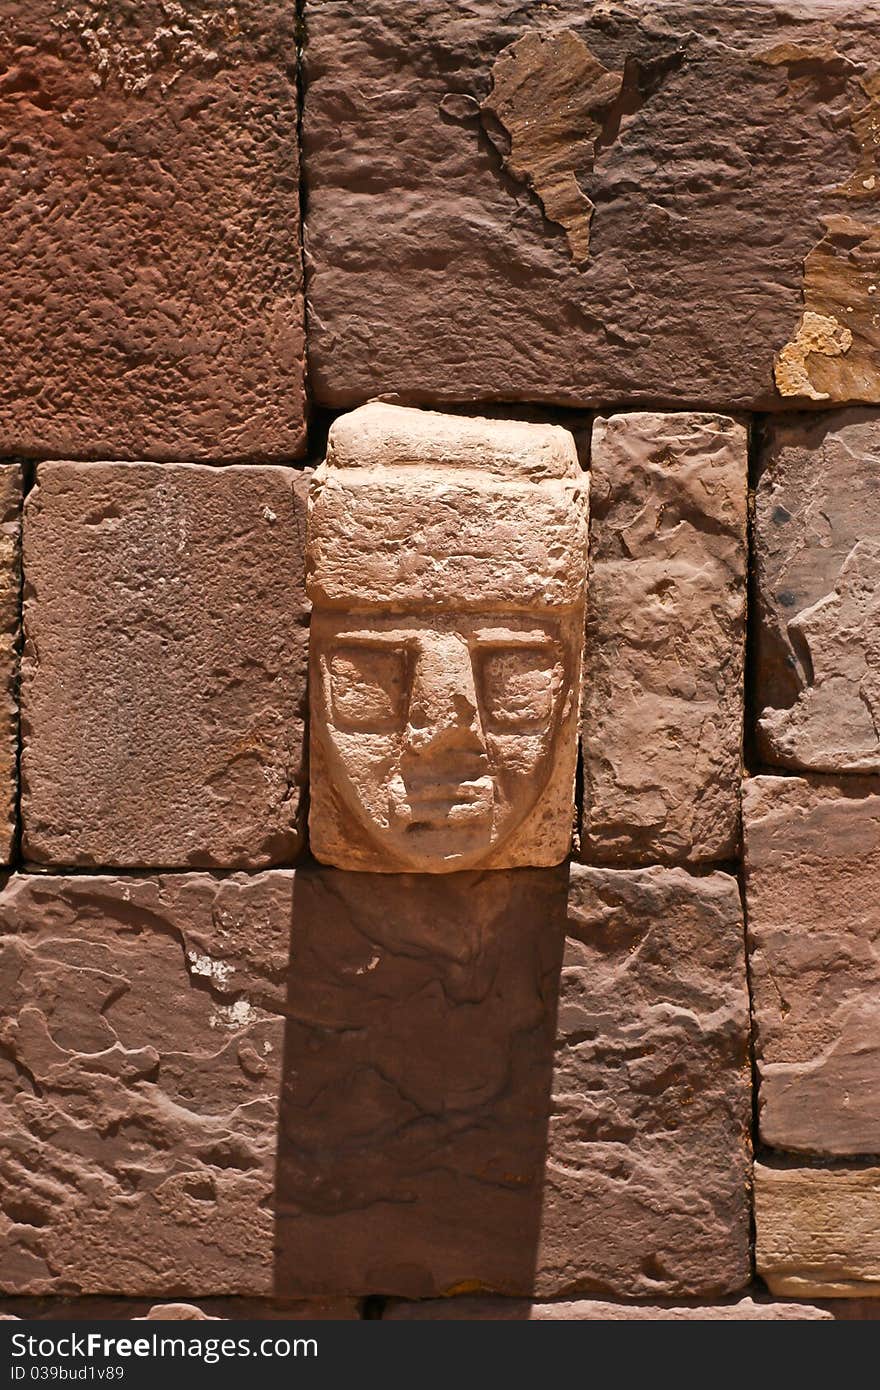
xmin=384 ymin=1298 xmax=834 ymax=1322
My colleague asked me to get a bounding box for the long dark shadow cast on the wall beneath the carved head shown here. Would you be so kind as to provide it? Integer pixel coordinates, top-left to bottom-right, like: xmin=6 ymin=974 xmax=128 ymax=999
xmin=275 ymin=865 xmax=569 ymax=1297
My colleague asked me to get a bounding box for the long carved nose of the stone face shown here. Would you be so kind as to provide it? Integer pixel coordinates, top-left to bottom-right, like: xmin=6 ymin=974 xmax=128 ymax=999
xmin=407 ymin=637 xmax=482 ymax=749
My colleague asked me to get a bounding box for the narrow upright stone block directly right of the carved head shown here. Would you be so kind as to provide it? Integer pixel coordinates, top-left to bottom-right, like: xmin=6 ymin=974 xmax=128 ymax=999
xmin=581 ymin=413 xmax=748 ymax=863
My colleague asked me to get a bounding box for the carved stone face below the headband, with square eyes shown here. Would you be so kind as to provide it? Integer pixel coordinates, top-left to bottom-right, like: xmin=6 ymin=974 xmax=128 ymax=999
xmin=311 ymin=613 xmax=580 ymax=872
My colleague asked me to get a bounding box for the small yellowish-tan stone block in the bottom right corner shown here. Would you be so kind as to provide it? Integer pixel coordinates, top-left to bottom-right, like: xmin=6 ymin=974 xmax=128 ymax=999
xmin=755 ymin=1163 xmax=880 ymax=1298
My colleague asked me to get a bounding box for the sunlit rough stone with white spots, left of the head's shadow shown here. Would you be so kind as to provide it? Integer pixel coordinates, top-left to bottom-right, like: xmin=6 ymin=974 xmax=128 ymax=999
xmin=0 ymin=870 xmax=293 ymax=1298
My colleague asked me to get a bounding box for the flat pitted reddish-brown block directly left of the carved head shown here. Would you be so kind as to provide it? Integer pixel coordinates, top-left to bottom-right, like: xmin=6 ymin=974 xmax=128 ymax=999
xmin=22 ymin=463 xmax=307 ymax=867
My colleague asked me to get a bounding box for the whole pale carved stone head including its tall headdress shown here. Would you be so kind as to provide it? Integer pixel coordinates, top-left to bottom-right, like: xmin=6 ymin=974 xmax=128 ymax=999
xmin=306 ymin=403 xmax=587 ymax=873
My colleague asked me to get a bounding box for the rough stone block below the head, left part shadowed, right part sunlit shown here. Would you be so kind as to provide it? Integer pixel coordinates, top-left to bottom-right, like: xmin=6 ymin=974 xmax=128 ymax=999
xmin=279 ymin=866 xmax=749 ymax=1300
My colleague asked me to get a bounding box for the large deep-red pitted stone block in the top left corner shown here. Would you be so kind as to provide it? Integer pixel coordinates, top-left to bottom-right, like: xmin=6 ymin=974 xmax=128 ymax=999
xmin=0 ymin=0 xmax=304 ymax=461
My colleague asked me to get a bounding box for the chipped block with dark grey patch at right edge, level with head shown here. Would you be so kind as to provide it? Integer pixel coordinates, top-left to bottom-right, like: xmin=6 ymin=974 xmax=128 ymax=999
xmin=755 ymin=405 xmax=880 ymax=773
